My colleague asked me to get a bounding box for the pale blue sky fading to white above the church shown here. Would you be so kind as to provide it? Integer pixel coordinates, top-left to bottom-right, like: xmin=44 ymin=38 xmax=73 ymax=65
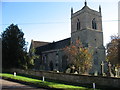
xmin=0 ymin=0 xmax=120 ymax=49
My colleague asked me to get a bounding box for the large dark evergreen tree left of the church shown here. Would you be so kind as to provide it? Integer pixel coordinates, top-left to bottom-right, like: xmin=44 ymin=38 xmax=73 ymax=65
xmin=1 ymin=24 xmax=26 ymax=68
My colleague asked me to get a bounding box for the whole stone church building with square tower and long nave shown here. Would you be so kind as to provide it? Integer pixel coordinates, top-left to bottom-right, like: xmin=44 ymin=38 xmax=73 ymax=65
xmin=30 ymin=2 xmax=105 ymax=73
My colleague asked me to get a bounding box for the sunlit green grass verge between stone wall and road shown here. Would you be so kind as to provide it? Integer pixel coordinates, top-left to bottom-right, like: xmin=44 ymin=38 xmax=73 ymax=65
xmin=0 ymin=73 xmax=92 ymax=90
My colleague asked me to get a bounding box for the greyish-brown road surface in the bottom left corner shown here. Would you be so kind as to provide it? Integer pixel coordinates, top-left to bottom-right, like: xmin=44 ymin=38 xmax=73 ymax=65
xmin=0 ymin=79 xmax=47 ymax=90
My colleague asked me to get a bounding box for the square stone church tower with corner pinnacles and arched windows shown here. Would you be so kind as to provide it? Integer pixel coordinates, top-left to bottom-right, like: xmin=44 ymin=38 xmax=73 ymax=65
xmin=71 ymin=1 xmax=105 ymax=73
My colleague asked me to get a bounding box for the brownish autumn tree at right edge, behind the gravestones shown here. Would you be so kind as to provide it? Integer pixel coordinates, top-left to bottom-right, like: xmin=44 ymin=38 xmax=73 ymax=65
xmin=107 ymin=35 xmax=120 ymax=67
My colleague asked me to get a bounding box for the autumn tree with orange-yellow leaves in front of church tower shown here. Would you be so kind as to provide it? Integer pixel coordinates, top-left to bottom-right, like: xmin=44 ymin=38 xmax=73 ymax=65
xmin=64 ymin=40 xmax=92 ymax=73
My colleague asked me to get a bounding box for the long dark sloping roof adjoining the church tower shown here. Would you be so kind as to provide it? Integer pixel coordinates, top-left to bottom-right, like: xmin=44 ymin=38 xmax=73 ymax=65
xmin=36 ymin=38 xmax=71 ymax=54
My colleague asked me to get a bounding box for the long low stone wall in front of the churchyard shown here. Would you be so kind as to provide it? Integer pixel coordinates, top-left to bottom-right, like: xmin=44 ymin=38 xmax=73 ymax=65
xmin=5 ymin=69 xmax=120 ymax=88
